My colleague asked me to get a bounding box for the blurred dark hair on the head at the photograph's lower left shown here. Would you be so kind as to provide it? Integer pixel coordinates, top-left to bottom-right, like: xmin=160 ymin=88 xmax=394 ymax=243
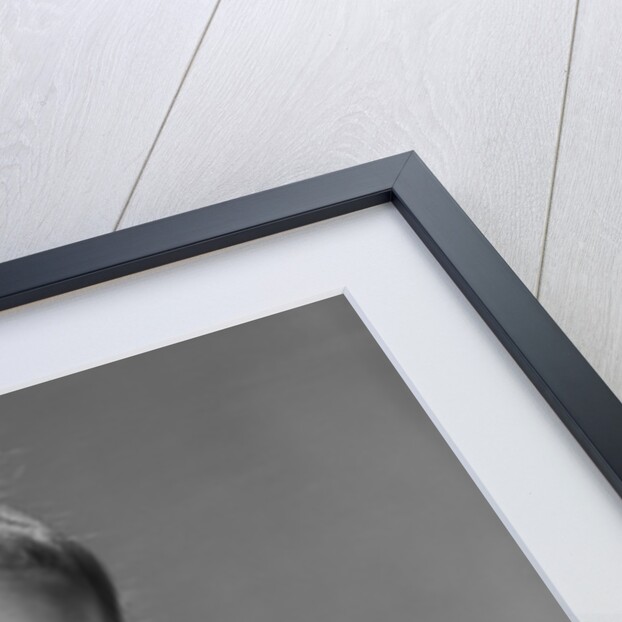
xmin=0 ymin=505 xmax=123 ymax=622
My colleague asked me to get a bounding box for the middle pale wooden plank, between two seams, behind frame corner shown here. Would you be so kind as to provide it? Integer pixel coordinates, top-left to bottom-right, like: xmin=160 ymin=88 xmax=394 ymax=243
xmin=121 ymin=0 xmax=574 ymax=288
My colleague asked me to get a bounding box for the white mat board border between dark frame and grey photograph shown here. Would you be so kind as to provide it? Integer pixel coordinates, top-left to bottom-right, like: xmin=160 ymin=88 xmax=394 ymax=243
xmin=0 ymin=205 xmax=622 ymax=622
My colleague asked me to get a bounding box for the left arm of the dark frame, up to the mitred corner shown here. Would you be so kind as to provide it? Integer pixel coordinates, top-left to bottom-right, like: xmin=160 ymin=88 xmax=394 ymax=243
xmin=0 ymin=152 xmax=410 ymax=311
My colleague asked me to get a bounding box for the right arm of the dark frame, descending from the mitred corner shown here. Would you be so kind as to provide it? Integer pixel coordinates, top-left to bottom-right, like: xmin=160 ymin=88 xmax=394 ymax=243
xmin=393 ymin=152 xmax=622 ymax=497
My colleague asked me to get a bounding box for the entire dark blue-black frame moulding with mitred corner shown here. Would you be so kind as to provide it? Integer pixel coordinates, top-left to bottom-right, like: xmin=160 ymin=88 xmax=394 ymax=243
xmin=0 ymin=152 xmax=622 ymax=496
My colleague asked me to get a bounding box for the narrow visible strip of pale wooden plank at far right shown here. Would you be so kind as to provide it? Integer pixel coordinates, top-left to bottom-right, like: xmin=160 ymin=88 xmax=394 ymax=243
xmin=540 ymin=0 xmax=622 ymax=398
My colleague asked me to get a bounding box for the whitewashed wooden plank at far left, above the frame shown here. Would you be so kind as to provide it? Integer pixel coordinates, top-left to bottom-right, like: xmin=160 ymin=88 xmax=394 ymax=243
xmin=0 ymin=0 xmax=215 ymax=261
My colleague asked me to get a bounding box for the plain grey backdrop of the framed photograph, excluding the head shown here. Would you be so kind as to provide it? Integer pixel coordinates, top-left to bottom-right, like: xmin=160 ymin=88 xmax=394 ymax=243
xmin=0 ymin=296 xmax=568 ymax=622
